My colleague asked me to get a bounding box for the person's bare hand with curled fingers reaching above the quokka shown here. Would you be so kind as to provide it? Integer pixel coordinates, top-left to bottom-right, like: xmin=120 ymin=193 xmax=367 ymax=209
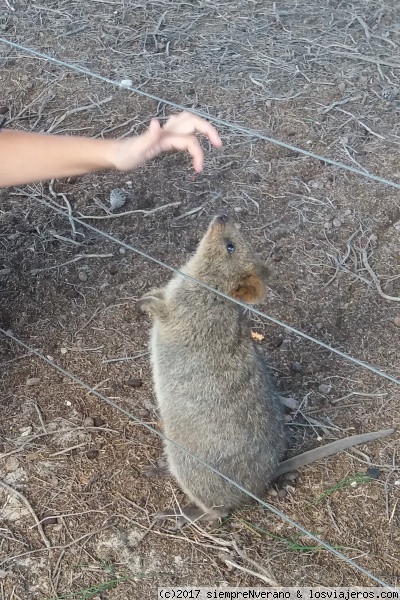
xmin=113 ymin=112 xmax=222 ymax=173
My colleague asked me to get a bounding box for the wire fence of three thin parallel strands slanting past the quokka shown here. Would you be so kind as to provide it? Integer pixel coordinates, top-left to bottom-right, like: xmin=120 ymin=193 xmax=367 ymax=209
xmin=0 ymin=37 xmax=400 ymax=590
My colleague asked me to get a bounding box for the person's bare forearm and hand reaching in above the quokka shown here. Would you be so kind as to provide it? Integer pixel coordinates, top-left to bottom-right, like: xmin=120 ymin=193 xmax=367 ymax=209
xmin=0 ymin=112 xmax=222 ymax=187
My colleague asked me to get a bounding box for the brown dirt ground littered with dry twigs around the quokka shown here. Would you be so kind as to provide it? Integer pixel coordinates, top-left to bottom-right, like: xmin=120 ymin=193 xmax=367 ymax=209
xmin=0 ymin=0 xmax=400 ymax=600
